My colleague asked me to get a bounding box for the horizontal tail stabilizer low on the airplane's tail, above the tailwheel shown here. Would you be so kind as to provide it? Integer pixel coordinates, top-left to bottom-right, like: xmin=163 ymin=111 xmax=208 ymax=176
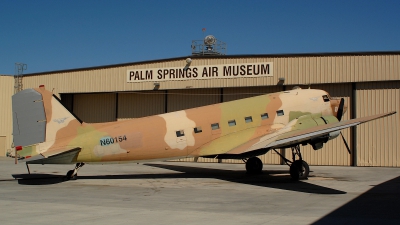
xmin=21 ymin=147 xmax=81 ymax=164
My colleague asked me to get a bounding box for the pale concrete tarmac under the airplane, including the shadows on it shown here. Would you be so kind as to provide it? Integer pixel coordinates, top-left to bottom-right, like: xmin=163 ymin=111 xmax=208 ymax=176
xmin=0 ymin=158 xmax=400 ymax=225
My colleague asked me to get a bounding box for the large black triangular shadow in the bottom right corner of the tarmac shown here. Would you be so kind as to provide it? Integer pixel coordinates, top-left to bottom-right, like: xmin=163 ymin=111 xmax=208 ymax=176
xmin=313 ymin=177 xmax=400 ymax=225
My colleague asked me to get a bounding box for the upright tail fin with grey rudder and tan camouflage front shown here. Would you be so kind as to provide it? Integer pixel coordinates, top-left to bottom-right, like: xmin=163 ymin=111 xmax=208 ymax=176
xmin=12 ymin=85 xmax=82 ymax=146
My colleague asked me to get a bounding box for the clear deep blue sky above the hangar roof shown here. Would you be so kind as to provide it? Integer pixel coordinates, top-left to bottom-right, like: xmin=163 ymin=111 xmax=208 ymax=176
xmin=0 ymin=0 xmax=400 ymax=75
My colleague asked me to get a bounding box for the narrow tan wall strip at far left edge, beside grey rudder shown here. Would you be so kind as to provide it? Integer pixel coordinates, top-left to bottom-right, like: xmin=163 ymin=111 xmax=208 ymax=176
xmin=0 ymin=76 xmax=14 ymax=156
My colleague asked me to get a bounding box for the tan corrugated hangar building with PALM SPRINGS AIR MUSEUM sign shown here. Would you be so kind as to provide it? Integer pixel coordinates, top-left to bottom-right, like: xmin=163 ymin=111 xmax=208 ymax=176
xmin=0 ymin=44 xmax=400 ymax=167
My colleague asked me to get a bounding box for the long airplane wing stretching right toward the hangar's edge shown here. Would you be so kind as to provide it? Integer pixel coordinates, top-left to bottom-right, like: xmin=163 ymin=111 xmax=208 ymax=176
xmin=220 ymin=112 xmax=396 ymax=158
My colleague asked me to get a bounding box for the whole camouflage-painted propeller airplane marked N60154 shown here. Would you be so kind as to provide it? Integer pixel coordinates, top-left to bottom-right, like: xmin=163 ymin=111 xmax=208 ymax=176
xmin=12 ymin=85 xmax=396 ymax=180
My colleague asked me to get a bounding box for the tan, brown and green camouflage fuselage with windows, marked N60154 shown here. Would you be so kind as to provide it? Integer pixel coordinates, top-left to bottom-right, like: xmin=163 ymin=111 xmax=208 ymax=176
xmin=55 ymin=89 xmax=338 ymax=162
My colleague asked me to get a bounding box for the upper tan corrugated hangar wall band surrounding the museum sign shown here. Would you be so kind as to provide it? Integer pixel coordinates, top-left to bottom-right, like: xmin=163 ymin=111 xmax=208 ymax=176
xmin=24 ymin=54 xmax=400 ymax=93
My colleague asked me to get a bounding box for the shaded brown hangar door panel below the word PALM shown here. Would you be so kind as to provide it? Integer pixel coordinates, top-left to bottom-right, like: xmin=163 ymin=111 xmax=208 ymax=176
xmin=117 ymin=91 xmax=165 ymax=120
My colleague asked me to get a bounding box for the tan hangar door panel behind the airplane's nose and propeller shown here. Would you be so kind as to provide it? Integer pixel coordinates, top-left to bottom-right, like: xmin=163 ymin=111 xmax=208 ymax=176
xmin=286 ymin=84 xmax=352 ymax=166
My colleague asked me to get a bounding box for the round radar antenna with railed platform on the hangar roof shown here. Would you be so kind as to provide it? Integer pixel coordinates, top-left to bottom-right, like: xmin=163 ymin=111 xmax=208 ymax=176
xmin=192 ymin=34 xmax=226 ymax=55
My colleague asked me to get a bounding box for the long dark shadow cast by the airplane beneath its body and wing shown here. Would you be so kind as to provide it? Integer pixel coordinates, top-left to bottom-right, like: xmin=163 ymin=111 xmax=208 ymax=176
xmin=13 ymin=163 xmax=346 ymax=194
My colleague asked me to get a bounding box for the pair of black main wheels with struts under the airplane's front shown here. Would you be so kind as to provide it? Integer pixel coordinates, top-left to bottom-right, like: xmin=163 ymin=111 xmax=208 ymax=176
xmin=243 ymin=145 xmax=310 ymax=180
